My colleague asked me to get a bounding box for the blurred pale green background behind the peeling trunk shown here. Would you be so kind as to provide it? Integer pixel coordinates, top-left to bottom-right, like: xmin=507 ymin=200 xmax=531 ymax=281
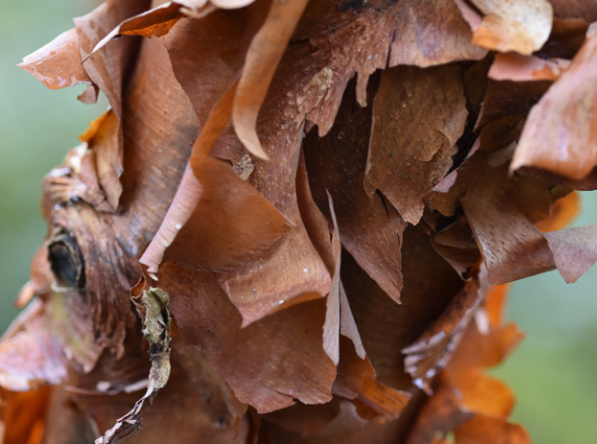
xmin=0 ymin=0 xmax=597 ymax=444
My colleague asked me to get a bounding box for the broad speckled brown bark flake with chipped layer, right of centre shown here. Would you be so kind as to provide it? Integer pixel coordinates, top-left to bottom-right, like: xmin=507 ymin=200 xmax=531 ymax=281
xmin=364 ymin=66 xmax=468 ymax=225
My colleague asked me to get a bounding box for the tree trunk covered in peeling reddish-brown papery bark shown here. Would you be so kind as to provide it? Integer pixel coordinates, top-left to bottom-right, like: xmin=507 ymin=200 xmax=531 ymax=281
xmin=0 ymin=0 xmax=597 ymax=444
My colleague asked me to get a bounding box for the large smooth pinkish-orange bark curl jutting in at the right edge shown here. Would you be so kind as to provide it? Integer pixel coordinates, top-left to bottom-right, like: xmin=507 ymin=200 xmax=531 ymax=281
xmin=511 ymin=25 xmax=597 ymax=180
